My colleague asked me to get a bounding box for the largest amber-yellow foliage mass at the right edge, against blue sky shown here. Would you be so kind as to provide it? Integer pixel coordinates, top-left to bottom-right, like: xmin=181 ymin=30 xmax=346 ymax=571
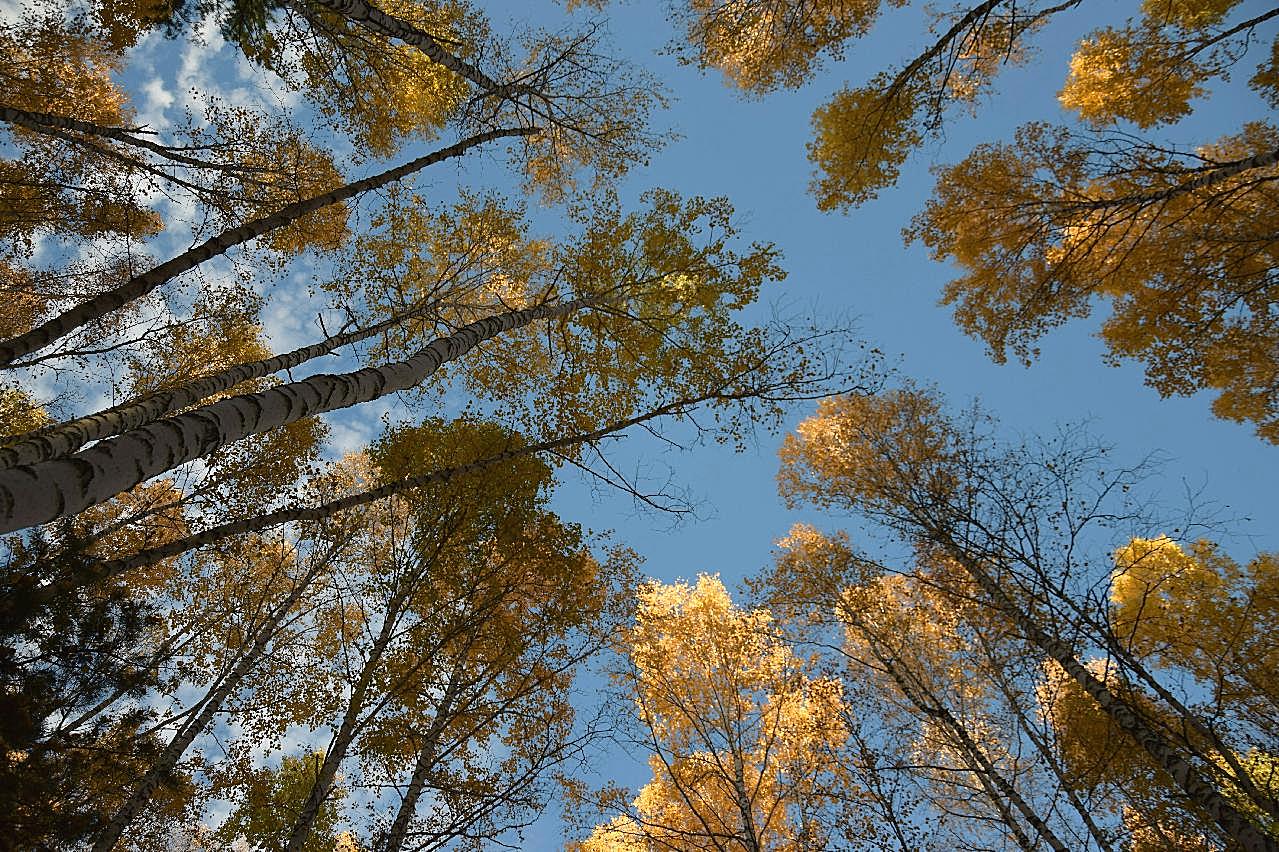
xmin=909 ymin=123 xmax=1279 ymax=441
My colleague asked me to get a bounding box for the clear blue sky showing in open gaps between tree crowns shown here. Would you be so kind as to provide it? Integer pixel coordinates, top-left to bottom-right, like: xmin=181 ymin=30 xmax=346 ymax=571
xmin=97 ymin=0 xmax=1279 ymax=844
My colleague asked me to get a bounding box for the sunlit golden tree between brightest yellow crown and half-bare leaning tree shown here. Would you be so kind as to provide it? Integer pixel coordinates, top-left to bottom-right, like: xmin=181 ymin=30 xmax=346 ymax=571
xmin=755 ymin=525 xmax=1113 ymax=849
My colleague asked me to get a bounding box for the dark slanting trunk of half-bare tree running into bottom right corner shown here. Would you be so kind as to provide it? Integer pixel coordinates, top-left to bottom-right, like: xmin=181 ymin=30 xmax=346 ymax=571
xmin=927 ymin=539 xmax=1279 ymax=852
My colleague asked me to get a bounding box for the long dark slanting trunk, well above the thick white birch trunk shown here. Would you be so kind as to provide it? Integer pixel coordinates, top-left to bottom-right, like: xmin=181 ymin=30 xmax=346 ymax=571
xmin=0 ymin=128 xmax=540 ymax=367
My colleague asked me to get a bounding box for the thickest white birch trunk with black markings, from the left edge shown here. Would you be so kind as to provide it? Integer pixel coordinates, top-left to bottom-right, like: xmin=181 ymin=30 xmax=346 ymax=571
xmin=0 ymin=299 xmax=593 ymax=532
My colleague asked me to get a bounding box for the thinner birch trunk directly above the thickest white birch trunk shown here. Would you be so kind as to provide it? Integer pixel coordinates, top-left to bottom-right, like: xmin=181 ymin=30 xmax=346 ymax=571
xmin=0 ymin=296 xmax=434 ymax=469
